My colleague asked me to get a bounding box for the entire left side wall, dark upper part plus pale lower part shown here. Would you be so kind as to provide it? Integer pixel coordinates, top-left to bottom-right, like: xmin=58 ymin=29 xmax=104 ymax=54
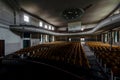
xmin=0 ymin=1 xmax=21 ymax=55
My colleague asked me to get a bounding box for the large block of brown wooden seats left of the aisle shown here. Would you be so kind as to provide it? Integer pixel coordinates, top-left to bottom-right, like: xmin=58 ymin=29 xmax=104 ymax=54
xmin=14 ymin=42 xmax=90 ymax=68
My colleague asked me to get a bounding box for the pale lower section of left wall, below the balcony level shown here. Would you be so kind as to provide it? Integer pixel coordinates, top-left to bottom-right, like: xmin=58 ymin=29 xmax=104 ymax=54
xmin=0 ymin=24 xmax=21 ymax=55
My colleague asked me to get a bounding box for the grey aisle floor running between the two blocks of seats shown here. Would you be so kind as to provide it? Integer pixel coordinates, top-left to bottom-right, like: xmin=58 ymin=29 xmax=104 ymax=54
xmin=81 ymin=44 xmax=108 ymax=80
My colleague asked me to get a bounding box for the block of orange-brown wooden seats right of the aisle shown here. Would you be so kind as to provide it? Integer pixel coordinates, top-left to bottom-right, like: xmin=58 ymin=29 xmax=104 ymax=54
xmin=86 ymin=42 xmax=120 ymax=80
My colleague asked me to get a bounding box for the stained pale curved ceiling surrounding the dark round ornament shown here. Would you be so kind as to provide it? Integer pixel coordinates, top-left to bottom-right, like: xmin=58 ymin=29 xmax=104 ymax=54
xmin=17 ymin=0 xmax=120 ymax=27
